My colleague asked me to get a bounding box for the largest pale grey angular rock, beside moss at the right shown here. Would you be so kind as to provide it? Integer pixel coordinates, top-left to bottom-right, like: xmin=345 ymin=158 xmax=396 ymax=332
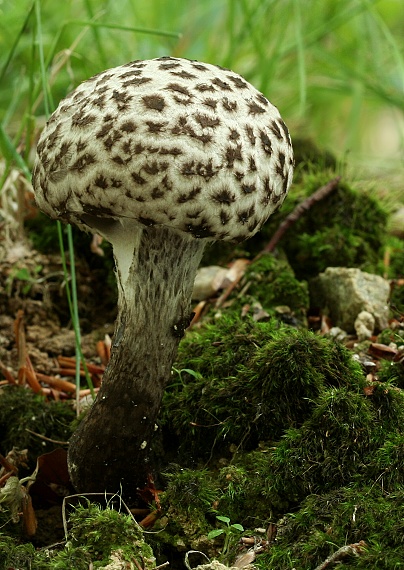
xmin=310 ymin=267 xmax=390 ymax=333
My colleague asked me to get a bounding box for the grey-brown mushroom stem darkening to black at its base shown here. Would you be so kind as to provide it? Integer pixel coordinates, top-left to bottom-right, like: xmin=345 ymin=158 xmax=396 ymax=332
xmin=68 ymin=226 xmax=205 ymax=497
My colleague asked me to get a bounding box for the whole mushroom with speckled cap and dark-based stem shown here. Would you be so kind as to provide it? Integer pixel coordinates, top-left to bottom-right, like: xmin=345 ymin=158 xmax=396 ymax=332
xmin=33 ymin=57 xmax=293 ymax=494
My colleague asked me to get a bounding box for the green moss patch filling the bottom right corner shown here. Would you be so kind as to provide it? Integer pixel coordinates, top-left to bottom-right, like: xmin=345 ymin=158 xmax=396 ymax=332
xmin=255 ymin=486 xmax=404 ymax=570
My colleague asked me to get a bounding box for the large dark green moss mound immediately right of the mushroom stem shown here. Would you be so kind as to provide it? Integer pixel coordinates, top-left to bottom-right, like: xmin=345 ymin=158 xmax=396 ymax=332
xmin=162 ymin=320 xmax=364 ymax=456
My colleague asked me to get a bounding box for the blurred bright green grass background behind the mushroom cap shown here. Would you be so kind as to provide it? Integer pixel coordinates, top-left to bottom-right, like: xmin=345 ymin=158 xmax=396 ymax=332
xmin=0 ymin=0 xmax=404 ymax=171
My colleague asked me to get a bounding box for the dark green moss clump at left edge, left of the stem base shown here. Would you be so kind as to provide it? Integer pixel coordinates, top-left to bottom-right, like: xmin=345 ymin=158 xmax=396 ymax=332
xmin=0 ymin=386 xmax=75 ymax=466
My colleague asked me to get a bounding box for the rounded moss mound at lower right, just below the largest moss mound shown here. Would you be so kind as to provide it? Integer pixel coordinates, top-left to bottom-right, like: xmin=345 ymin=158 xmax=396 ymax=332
xmin=258 ymin=387 xmax=376 ymax=508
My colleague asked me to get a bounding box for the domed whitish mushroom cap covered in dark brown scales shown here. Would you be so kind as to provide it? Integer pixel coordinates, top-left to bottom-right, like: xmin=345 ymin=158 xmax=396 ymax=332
xmin=33 ymin=53 xmax=293 ymax=241
